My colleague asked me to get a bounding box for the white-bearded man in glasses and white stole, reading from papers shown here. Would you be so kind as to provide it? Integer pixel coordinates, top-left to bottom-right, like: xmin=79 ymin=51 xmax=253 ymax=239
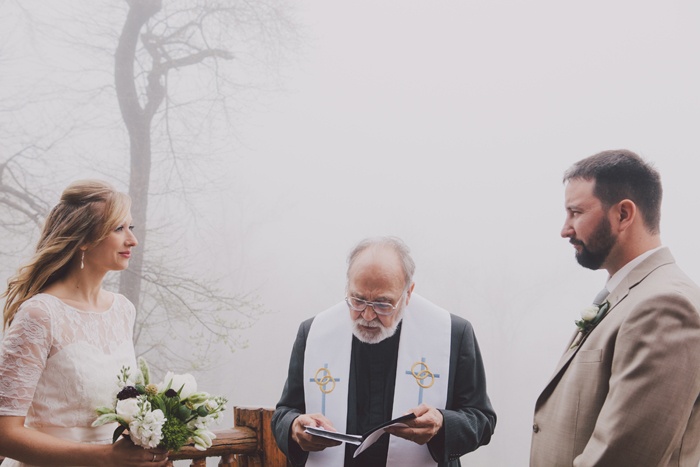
xmin=272 ymin=237 xmax=496 ymax=467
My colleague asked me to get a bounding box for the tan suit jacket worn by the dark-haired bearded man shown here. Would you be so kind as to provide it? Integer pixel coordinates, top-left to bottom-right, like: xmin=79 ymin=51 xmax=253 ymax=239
xmin=530 ymin=248 xmax=700 ymax=467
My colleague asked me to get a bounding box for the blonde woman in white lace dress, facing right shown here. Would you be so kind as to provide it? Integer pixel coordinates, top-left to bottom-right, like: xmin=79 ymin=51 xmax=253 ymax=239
xmin=0 ymin=180 xmax=168 ymax=467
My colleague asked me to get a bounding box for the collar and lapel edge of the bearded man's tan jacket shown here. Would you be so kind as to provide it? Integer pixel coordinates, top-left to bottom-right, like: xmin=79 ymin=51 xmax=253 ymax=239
xmin=537 ymin=248 xmax=674 ymax=405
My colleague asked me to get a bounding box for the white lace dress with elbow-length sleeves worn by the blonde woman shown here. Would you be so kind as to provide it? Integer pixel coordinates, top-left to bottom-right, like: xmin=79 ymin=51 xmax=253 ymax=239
xmin=0 ymin=294 xmax=136 ymax=467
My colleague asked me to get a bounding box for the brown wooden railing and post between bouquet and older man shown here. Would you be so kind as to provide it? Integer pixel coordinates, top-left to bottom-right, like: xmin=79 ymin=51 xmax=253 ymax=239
xmin=169 ymin=407 xmax=287 ymax=467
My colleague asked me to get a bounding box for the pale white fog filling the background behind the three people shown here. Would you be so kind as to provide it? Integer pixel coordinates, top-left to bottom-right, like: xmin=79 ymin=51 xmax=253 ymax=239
xmin=0 ymin=0 xmax=700 ymax=467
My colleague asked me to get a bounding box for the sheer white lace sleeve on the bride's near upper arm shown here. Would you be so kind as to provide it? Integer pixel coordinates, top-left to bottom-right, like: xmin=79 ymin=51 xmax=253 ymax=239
xmin=0 ymin=301 xmax=52 ymax=416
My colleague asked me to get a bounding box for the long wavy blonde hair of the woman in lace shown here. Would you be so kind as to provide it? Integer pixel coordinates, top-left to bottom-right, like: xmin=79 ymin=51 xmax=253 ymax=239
xmin=2 ymin=180 xmax=131 ymax=328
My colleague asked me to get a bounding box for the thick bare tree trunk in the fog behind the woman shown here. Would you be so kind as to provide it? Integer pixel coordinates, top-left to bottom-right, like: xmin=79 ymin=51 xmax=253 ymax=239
xmin=114 ymin=0 xmax=232 ymax=306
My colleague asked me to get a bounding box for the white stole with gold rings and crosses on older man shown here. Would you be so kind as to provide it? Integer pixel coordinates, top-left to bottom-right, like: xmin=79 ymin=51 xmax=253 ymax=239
xmin=304 ymin=294 xmax=451 ymax=467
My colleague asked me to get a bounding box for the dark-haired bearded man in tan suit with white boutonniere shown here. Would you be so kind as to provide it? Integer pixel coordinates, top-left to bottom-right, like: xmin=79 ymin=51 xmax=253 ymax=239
xmin=530 ymin=150 xmax=700 ymax=467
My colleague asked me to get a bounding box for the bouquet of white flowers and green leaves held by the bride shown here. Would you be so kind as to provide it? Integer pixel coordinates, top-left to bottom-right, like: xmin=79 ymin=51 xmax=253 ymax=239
xmin=92 ymin=358 xmax=227 ymax=451
